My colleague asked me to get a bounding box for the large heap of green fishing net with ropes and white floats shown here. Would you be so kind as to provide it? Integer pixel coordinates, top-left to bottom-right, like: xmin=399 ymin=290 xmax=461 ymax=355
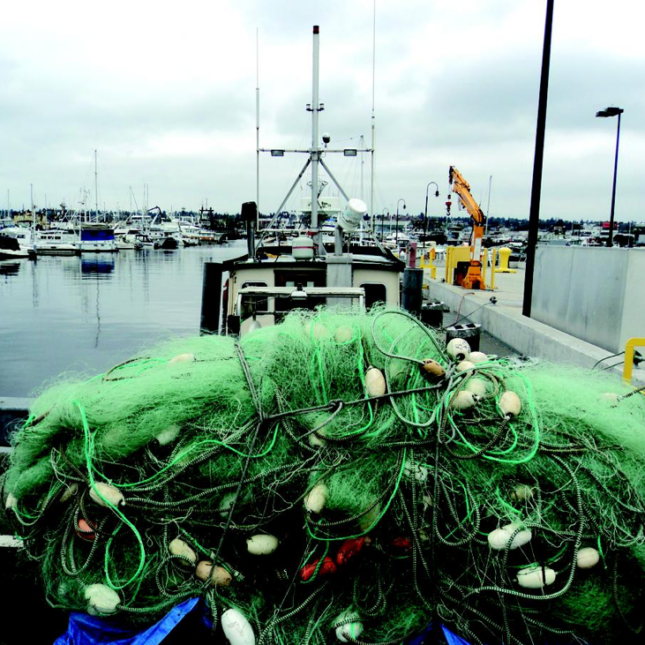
xmin=3 ymin=309 xmax=645 ymax=644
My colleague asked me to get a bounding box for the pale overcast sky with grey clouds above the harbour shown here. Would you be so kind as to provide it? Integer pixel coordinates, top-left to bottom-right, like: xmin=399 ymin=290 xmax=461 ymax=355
xmin=0 ymin=0 xmax=645 ymax=221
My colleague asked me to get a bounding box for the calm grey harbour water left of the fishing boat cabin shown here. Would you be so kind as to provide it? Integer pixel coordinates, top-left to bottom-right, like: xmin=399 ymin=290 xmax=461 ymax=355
xmin=0 ymin=242 xmax=246 ymax=397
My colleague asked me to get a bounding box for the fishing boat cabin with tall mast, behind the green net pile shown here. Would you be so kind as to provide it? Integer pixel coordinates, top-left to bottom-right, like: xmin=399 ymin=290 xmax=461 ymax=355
xmin=211 ymin=26 xmax=405 ymax=335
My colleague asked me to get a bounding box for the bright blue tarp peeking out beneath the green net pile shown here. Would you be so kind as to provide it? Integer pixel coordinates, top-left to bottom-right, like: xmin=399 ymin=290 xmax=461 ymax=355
xmin=54 ymin=598 xmax=469 ymax=645
